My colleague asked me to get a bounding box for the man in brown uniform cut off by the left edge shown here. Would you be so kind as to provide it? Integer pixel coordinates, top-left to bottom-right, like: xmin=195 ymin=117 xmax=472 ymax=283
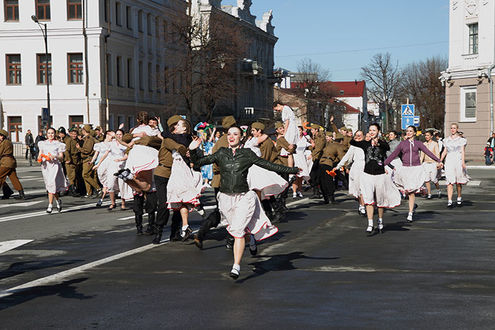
xmin=0 ymin=129 xmax=25 ymax=199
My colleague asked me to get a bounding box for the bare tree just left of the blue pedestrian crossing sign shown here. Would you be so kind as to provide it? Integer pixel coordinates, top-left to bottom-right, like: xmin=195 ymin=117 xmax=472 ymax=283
xmin=361 ymin=53 xmax=402 ymax=130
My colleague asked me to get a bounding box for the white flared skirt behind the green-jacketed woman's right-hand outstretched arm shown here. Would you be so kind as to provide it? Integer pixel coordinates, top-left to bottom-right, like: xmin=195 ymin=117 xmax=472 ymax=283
xmin=247 ymin=165 xmax=289 ymax=200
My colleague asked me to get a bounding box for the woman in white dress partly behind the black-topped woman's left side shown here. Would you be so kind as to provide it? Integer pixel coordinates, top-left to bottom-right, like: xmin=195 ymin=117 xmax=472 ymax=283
xmin=333 ymin=131 xmax=366 ymax=216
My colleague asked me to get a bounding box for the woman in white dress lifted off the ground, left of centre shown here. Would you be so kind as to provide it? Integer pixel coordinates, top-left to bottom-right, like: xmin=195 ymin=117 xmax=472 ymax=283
xmin=118 ymin=111 xmax=161 ymax=194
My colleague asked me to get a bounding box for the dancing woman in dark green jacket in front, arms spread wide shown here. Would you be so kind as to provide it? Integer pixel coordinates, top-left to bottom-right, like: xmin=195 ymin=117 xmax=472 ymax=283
xmin=189 ymin=126 xmax=299 ymax=279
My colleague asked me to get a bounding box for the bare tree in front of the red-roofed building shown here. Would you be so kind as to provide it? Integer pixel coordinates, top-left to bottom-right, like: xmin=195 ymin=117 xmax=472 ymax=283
xmin=293 ymin=59 xmax=342 ymax=127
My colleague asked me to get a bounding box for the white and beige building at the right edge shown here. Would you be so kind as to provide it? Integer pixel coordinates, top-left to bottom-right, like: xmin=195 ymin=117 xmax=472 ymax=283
xmin=441 ymin=0 xmax=495 ymax=159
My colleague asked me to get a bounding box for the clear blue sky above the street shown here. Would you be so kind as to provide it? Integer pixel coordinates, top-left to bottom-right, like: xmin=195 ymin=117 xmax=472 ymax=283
xmin=222 ymin=0 xmax=449 ymax=81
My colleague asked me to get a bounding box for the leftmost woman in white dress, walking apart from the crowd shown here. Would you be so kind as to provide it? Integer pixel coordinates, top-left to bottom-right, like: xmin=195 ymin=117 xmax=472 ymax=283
xmin=38 ymin=127 xmax=68 ymax=213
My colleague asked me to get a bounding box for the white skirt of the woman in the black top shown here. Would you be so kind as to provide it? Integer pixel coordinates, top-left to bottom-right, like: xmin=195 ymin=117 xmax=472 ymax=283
xmin=359 ymin=172 xmax=401 ymax=208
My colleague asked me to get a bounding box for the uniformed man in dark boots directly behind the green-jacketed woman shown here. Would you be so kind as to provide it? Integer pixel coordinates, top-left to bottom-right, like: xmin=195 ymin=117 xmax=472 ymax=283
xmin=194 ymin=116 xmax=236 ymax=249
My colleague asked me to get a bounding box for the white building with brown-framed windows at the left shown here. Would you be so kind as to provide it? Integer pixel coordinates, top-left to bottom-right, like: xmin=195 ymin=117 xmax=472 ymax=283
xmin=0 ymin=0 xmax=187 ymax=141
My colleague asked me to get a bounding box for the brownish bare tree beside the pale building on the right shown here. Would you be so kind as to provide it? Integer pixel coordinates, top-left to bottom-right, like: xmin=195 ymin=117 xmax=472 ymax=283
xmin=400 ymin=57 xmax=448 ymax=128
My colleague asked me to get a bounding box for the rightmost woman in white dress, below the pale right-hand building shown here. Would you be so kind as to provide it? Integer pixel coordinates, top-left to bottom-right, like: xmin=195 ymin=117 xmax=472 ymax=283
xmin=441 ymin=123 xmax=469 ymax=208
